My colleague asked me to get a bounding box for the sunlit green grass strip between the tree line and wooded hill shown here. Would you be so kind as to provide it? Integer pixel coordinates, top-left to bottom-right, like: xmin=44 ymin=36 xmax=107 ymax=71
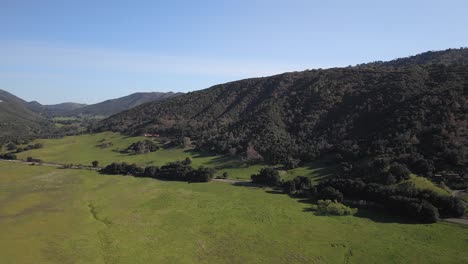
xmin=10 ymin=132 xmax=328 ymax=179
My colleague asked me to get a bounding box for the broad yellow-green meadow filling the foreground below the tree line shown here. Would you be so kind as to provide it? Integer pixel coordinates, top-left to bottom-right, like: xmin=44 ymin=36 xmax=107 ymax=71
xmin=0 ymin=162 xmax=468 ymax=264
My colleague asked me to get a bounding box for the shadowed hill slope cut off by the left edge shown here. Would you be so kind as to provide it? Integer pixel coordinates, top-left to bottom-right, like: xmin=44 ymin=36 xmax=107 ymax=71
xmin=0 ymin=90 xmax=52 ymax=142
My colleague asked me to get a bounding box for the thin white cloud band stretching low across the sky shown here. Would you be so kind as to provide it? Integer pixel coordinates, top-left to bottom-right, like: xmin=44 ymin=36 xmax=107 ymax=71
xmin=0 ymin=40 xmax=318 ymax=77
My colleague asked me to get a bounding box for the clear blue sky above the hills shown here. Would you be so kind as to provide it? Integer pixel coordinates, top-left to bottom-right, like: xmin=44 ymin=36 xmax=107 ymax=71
xmin=0 ymin=0 xmax=468 ymax=104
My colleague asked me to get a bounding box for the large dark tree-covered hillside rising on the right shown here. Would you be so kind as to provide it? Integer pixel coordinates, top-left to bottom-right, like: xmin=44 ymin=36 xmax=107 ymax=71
xmin=97 ymin=49 xmax=468 ymax=174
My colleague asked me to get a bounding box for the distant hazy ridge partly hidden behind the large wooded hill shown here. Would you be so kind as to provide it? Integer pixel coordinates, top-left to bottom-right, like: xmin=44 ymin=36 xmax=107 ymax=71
xmin=66 ymin=92 xmax=182 ymax=116
